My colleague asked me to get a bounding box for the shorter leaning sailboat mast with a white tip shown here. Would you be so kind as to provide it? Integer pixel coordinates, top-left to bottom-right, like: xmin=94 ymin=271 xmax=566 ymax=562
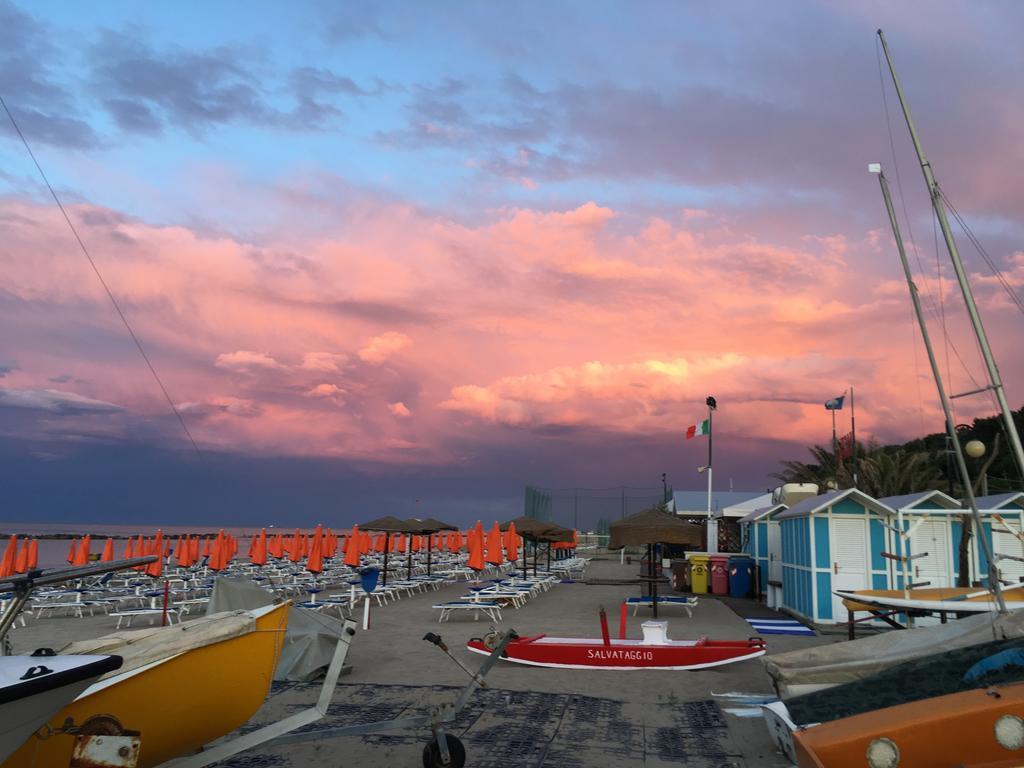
xmin=868 ymin=165 xmax=1007 ymax=613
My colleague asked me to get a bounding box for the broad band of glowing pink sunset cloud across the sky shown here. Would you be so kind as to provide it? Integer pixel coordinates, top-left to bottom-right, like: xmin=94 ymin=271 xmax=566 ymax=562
xmin=0 ymin=192 xmax=1024 ymax=463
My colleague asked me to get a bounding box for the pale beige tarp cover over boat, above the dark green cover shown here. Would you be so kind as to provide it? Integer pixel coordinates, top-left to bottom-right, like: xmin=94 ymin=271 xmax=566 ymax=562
xmin=761 ymin=611 xmax=1024 ymax=698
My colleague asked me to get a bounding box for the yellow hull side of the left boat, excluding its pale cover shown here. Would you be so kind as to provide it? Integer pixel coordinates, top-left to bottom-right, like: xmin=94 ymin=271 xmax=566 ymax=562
xmin=2 ymin=603 xmax=290 ymax=768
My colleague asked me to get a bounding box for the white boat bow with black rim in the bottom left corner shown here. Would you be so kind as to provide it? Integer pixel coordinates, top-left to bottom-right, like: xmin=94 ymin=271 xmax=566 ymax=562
xmin=0 ymin=656 xmax=121 ymax=763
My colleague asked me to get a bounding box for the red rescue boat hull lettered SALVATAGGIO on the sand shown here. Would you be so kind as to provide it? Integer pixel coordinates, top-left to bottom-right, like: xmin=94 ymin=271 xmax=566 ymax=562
xmin=466 ymin=635 xmax=765 ymax=672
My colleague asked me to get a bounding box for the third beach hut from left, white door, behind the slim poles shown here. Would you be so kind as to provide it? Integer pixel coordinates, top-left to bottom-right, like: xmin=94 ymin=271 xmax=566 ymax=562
xmin=879 ymin=490 xmax=962 ymax=589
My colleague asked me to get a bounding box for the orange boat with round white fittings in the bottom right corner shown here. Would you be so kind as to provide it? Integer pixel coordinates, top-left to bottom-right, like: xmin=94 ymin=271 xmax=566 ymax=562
xmin=793 ymin=683 xmax=1024 ymax=768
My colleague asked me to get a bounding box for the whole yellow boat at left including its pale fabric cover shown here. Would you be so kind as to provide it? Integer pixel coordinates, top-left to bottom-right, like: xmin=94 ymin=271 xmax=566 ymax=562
xmin=2 ymin=603 xmax=290 ymax=768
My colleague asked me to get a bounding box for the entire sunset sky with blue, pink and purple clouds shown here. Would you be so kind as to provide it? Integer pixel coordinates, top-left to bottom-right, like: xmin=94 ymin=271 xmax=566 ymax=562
xmin=0 ymin=0 xmax=1024 ymax=524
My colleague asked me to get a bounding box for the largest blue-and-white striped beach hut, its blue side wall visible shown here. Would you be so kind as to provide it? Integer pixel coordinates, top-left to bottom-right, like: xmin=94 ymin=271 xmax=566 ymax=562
xmin=774 ymin=488 xmax=896 ymax=624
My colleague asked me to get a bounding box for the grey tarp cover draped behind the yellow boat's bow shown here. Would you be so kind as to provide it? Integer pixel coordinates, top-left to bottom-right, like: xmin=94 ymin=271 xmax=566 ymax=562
xmin=207 ymin=579 xmax=343 ymax=682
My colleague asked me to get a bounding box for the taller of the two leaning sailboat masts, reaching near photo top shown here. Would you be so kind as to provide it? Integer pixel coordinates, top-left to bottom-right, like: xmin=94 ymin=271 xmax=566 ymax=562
xmin=879 ymin=30 xmax=1024 ymax=487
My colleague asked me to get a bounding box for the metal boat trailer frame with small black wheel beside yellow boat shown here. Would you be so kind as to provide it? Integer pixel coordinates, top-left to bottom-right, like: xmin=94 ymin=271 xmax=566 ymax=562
xmin=159 ymin=618 xmax=517 ymax=768
